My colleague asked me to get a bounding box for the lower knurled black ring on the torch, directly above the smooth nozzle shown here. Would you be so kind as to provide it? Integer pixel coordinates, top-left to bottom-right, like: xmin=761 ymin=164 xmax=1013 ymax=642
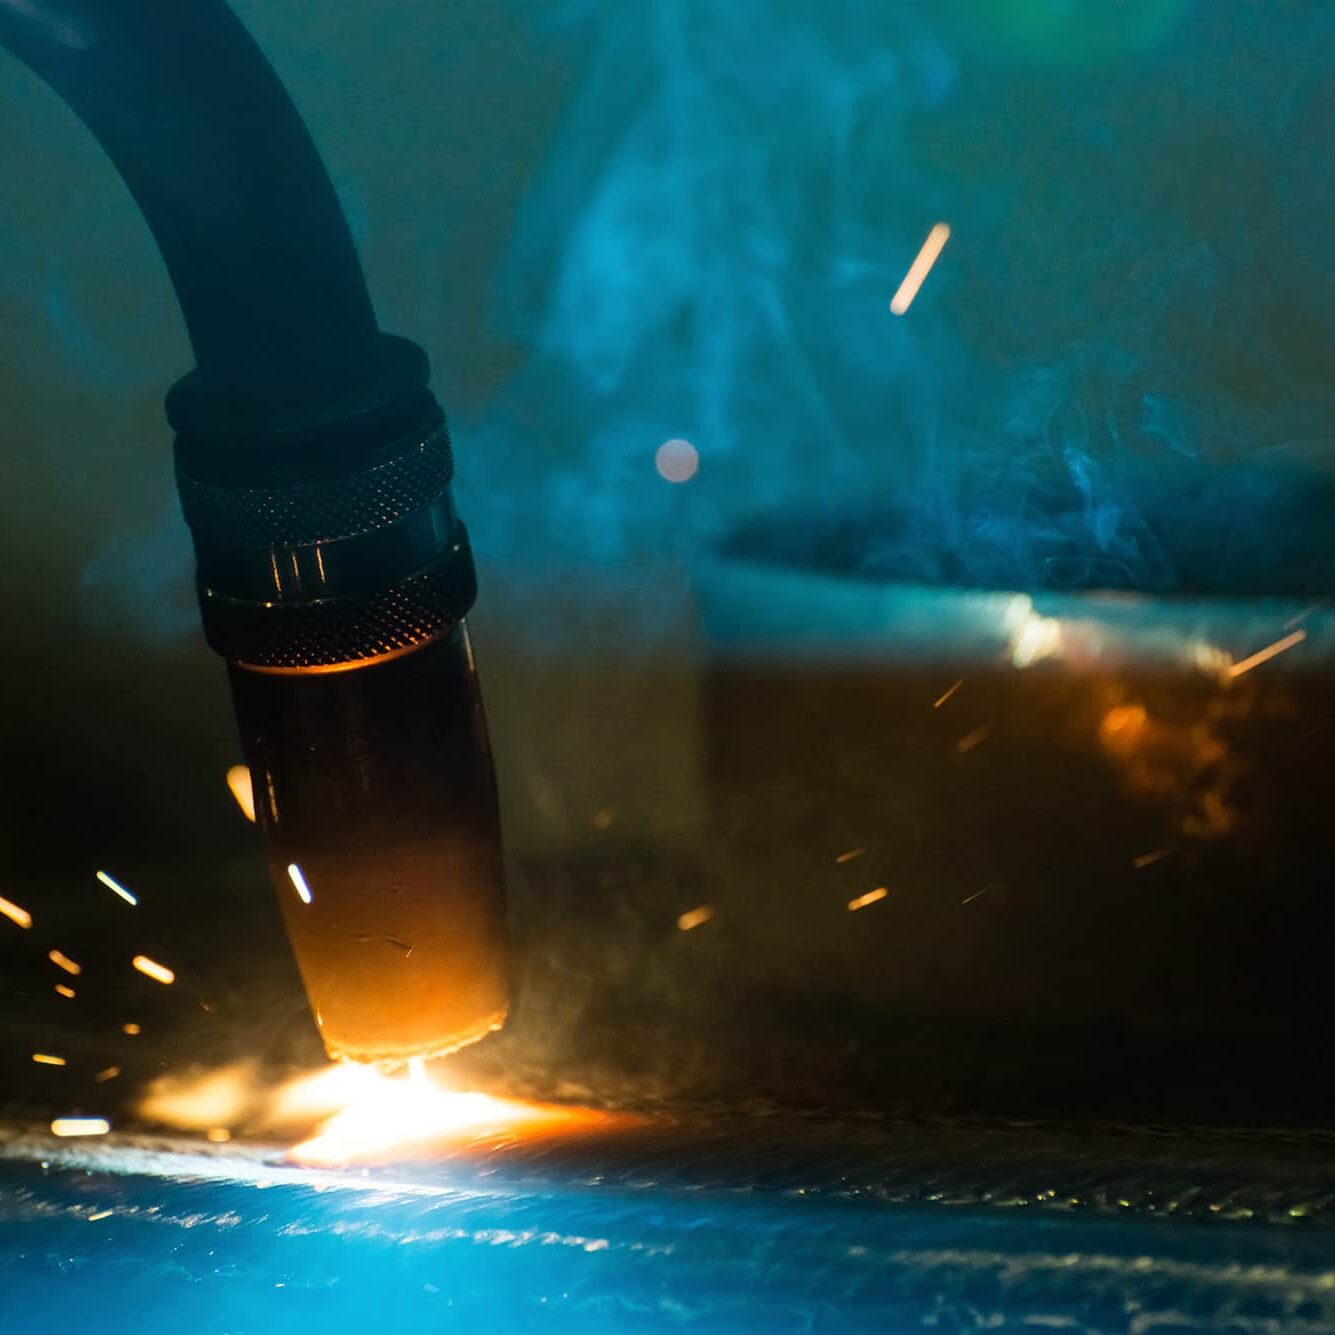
xmin=200 ymin=536 xmax=477 ymax=672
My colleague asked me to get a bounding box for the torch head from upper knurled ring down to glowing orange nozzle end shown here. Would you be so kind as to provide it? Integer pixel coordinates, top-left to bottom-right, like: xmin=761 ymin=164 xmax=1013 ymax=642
xmin=176 ymin=340 xmax=507 ymax=1064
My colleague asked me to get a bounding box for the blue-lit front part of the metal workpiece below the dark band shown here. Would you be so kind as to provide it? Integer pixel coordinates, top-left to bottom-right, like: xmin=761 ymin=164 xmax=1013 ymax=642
xmin=0 ymin=1159 xmax=1335 ymax=1335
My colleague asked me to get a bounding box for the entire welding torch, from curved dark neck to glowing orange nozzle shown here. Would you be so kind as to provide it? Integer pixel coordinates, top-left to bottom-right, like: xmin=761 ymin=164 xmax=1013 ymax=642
xmin=0 ymin=0 xmax=507 ymax=1064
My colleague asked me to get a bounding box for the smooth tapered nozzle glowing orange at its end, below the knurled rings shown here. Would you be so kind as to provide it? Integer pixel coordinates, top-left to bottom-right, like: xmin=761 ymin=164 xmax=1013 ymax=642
xmin=234 ymin=626 xmax=509 ymax=1065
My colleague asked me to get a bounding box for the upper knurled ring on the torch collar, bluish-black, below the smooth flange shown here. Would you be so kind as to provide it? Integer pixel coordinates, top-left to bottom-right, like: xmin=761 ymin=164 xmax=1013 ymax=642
xmin=176 ymin=422 xmax=454 ymax=550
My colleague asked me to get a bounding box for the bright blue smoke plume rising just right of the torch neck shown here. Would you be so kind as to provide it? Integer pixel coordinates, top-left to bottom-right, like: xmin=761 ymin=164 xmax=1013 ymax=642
xmin=466 ymin=3 xmax=960 ymax=562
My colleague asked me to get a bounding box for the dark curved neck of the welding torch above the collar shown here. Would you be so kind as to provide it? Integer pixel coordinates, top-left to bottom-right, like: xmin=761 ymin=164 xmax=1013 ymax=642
xmin=0 ymin=0 xmax=384 ymax=434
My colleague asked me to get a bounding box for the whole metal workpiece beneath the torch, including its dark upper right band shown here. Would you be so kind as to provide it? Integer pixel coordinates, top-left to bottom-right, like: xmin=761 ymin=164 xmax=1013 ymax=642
xmin=0 ymin=1121 xmax=1335 ymax=1335
